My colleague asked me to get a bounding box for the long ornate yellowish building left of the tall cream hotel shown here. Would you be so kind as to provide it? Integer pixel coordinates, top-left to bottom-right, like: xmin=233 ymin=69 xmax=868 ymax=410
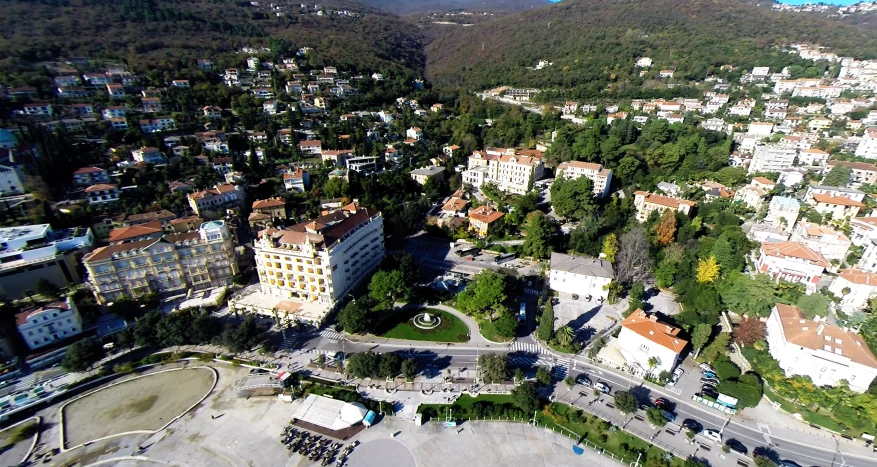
xmin=82 ymin=221 xmax=238 ymax=303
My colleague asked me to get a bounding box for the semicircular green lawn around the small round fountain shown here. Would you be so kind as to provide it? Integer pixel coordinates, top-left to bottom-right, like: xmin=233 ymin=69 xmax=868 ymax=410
xmin=376 ymin=308 xmax=469 ymax=342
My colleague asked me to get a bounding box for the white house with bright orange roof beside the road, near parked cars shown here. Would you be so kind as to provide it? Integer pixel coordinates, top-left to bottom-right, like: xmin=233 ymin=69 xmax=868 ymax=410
xmin=616 ymin=310 xmax=688 ymax=375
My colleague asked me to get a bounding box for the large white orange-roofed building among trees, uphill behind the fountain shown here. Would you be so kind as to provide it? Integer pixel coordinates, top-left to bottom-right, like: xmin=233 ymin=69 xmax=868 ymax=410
xmin=463 ymin=148 xmax=545 ymax=195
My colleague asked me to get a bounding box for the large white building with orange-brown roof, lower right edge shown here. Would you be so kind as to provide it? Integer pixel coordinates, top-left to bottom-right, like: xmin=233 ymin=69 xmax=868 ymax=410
xmin=767 ymin=303 xmax=877 ymax=392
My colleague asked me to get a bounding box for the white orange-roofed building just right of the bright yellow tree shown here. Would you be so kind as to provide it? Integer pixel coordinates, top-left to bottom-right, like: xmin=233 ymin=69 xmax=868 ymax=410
xmin=755 ymin=242 xmax=831 ymax=294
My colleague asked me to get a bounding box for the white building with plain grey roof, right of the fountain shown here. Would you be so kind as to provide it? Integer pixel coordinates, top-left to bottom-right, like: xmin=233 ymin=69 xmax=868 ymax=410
xmin=548 ymin=253 xmax=615 ymax=302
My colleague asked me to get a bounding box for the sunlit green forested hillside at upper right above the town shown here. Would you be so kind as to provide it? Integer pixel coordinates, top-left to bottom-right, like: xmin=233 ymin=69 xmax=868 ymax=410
xmin=427 ymin=0 xmax=877 ymax=97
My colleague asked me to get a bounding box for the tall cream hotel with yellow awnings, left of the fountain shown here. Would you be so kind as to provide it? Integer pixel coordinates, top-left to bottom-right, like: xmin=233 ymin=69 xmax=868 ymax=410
xmin=230 ymin=203 xmax=384 ymax=324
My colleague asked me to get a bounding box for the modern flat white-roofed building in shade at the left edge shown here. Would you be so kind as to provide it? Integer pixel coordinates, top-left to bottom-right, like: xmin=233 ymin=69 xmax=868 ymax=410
xmin=0 ymin=224 xmax=94 ymax=299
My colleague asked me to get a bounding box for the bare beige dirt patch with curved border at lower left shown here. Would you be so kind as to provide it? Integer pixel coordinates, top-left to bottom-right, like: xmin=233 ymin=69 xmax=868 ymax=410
xmin=63 ymin=367 xmax=213 ymax=447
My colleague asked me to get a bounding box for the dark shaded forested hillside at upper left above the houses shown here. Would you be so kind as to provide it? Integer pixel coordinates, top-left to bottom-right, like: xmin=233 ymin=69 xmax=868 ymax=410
xmin=0 ymin=0 xmax=424 ymax=77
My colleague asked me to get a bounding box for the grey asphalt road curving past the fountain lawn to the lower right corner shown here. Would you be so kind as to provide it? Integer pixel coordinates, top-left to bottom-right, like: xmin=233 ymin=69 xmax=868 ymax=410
xmin=309 ymin=339 xmax=877 ymax=467
